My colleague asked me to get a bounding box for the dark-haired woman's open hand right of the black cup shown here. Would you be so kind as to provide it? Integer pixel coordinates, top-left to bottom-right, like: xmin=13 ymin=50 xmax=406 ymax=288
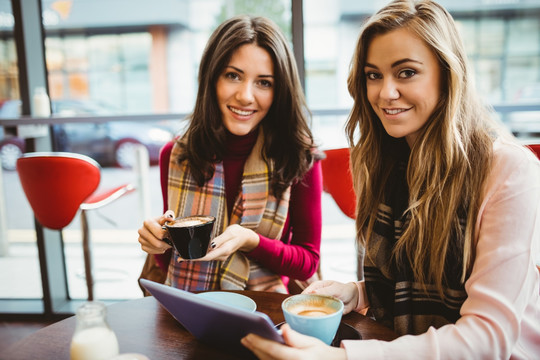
xmin=197 ymin=224 xmax=260 ymax=261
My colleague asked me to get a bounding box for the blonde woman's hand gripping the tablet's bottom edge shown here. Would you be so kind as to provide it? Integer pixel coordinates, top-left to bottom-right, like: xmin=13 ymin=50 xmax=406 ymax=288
xmin=242 ymin=324 xmax=347 ymax=360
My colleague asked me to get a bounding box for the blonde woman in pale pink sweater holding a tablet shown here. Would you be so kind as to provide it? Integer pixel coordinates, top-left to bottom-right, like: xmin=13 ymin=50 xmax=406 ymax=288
xmin=243 ymin=0 xmax=540 ymax=359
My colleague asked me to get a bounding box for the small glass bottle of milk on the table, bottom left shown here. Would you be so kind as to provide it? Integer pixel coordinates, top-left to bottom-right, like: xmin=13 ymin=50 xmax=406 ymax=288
xmin=70 ymin=301 xmax=119 ymax=360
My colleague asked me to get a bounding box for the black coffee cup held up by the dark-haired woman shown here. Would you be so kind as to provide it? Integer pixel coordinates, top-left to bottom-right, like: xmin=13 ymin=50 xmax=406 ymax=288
xmin=163 ymin=215 xmax=216 ymax=259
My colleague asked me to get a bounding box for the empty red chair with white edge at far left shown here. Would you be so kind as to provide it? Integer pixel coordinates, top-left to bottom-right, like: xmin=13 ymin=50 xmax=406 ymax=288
xmin=17 ymin=152 xmax=135 ymax=300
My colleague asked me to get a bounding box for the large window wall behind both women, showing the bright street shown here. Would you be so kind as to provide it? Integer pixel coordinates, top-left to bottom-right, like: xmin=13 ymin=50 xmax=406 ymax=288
xmin=0 ymin=0 xmax=540 ymax=316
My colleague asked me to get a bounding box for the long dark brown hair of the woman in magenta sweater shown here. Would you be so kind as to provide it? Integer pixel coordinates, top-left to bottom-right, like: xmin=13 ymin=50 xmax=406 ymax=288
xmin=179 ymin=15 xmax=314 ymax=196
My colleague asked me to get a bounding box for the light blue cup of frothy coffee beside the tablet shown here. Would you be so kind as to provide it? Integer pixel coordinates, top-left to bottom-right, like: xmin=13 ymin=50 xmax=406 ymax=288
xmin=281 ymin=294 xmax=344 ymax=345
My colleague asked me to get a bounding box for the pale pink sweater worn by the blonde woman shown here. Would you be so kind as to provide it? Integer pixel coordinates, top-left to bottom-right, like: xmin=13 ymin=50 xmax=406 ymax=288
xmin=341 ymin=140 xmax=540 ymax=360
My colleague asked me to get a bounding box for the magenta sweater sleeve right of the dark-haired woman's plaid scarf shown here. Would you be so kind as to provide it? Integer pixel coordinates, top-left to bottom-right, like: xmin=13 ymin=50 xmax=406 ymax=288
xmin=247 ymin=161 xmax=322 ymax=280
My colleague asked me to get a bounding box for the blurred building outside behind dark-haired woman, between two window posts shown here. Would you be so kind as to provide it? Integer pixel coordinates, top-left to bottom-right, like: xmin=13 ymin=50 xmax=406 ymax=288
xmin=43 ymin=0 xmax=292 ymax=113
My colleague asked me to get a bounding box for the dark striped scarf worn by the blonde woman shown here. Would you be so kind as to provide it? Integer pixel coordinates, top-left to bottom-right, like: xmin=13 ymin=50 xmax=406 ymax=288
xmin=364 ymin=156 xmax=467 ymax=335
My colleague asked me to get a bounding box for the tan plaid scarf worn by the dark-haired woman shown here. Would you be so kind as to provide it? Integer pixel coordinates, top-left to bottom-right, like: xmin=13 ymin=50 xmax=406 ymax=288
xmin=166 ymin=130 xmax=290 ymax=293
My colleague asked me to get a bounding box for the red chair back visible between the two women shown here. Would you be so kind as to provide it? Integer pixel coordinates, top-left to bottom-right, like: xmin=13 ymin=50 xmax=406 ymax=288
xmin=321 ymin=148 xmax=356 ymax=219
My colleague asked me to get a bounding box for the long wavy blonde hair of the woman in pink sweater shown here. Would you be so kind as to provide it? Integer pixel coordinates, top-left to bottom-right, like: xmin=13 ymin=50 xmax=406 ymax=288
xmin=346 ymin=0 xmax=497 ymax=295
